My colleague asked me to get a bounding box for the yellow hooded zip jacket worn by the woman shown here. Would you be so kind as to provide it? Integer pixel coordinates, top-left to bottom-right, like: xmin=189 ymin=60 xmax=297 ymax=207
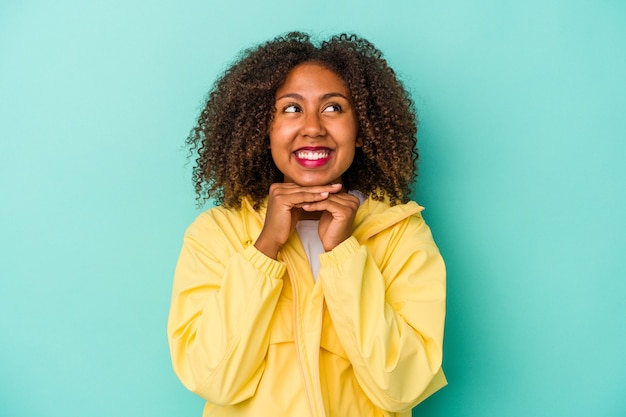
xmin=168 ymin=195 xmax=446 ymax=417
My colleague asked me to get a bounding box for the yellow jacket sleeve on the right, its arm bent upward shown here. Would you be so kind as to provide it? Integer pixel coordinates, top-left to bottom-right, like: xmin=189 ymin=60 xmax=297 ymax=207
xmin=319 ymin=215 xmax=446 ymax=412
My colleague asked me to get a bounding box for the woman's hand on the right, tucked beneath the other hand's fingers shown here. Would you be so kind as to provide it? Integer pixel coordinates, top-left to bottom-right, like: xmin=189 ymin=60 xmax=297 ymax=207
xmin=302 ymin=188 xmax=360 ymax=252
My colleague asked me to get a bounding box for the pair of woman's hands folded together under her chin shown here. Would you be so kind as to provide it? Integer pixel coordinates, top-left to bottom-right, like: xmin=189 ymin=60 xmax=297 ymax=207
xmin=254 ymin=183 xmax=359 ymax=259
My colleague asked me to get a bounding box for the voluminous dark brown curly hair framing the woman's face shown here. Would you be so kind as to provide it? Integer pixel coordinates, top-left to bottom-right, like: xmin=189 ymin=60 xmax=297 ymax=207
xmin=186 ymin=32 xmax=418 ymax=209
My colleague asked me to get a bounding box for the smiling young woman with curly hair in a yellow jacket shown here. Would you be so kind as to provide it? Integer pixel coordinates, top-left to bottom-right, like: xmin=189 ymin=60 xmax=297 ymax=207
xmin=168 ymin=33 xmax=446 ymax=416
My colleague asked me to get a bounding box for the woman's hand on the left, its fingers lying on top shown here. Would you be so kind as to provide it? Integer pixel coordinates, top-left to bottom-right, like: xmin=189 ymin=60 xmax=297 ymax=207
xmin=254 ymin=183 xmax=342 ymax=259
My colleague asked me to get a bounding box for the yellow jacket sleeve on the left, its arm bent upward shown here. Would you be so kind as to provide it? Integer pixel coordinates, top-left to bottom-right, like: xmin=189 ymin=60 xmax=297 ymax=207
xmin=168 ymin=213 xmax=285 ymax=405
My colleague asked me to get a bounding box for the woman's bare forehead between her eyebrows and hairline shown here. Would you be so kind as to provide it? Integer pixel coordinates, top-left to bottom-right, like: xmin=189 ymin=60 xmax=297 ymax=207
xmin=276 ymin=62 xmax=349 ymax=96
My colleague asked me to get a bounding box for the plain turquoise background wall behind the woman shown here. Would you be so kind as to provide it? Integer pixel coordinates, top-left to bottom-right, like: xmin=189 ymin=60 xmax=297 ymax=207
xmin=0 ymin=0 xmax=626 ymax=417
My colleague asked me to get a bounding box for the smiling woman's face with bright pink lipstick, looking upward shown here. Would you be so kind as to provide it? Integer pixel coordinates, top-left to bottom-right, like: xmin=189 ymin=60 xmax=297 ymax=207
xmin=269 ymin=62 xmax=362 ymax=186
